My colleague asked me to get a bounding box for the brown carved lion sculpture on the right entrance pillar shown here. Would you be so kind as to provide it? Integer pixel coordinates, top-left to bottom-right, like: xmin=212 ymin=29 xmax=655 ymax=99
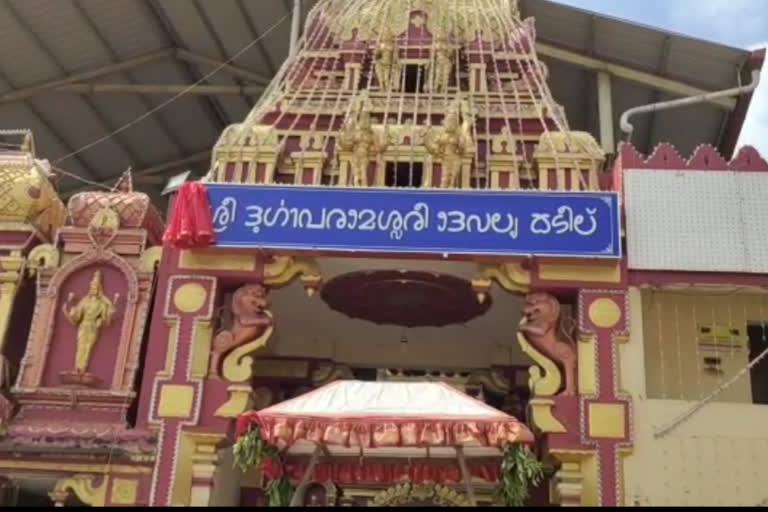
xmin=519 ymin=293 xmax=577 ymax=395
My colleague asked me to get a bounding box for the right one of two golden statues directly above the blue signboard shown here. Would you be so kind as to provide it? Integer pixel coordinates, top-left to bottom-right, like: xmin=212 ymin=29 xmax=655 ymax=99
xmin=425 ymin=100 xmax=474 ymax=188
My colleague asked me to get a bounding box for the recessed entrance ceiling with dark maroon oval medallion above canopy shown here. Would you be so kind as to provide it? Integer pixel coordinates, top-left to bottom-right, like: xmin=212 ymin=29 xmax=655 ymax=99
xmin=260 ymin=258 xmax=529 ymax=382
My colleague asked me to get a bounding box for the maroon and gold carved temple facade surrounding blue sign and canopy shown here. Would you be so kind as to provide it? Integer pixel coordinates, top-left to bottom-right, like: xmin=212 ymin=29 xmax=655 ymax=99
xmin=0 ymin=0 xmax=768 ymax=506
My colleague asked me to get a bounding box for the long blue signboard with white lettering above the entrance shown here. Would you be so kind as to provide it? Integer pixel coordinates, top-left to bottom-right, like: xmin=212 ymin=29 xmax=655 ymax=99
xmin=206 ymin=183 xmax=621 ymax=258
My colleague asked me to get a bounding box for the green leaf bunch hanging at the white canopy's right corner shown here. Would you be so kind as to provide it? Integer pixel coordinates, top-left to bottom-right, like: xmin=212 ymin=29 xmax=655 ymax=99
xmin=496 ymin=444 xmax=544 ymax=507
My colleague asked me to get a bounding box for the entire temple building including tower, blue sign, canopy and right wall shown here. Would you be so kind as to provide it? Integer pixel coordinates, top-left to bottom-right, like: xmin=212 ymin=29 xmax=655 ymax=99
xmin=0 ymin=0 xmax=768 ymax=507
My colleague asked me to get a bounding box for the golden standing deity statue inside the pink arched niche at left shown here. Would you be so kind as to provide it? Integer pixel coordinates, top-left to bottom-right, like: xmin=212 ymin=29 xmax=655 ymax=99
xmin=62 ymin=271 xmax=120 ymax=374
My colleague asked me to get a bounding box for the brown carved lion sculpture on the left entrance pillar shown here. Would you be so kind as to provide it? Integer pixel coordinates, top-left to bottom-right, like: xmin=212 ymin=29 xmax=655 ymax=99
xmin=209 ymin=284 xmax=272 ymax=376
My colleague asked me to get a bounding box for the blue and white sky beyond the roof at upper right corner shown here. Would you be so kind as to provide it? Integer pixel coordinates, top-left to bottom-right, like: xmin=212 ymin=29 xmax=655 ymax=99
xmin=555 ymin=0 xmax=768 ymax=159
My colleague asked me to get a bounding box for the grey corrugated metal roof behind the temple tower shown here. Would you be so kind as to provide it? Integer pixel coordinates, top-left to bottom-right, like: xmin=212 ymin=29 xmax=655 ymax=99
xmin=0 ymin=0 xmax=750 ymax=198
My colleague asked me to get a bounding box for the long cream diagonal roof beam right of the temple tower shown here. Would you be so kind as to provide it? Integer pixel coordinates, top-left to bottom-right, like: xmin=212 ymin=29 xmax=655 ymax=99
xmin=536 ymin=42 xmax=736 ymax=110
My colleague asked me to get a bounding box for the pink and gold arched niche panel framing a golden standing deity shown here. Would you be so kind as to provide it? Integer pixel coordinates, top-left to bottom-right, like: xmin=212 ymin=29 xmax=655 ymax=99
xmin=9 ymin=184 xmax=159 ymax=440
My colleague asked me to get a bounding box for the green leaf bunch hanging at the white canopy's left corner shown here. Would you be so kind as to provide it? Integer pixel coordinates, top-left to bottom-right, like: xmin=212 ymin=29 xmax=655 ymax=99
xmin=233 ymin=424 xmax=296 ymax=507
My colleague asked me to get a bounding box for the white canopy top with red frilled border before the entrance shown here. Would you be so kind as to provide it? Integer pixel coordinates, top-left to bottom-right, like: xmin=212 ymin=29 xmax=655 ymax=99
xmin=238 ymin=381 xmax=533 ymax=457
